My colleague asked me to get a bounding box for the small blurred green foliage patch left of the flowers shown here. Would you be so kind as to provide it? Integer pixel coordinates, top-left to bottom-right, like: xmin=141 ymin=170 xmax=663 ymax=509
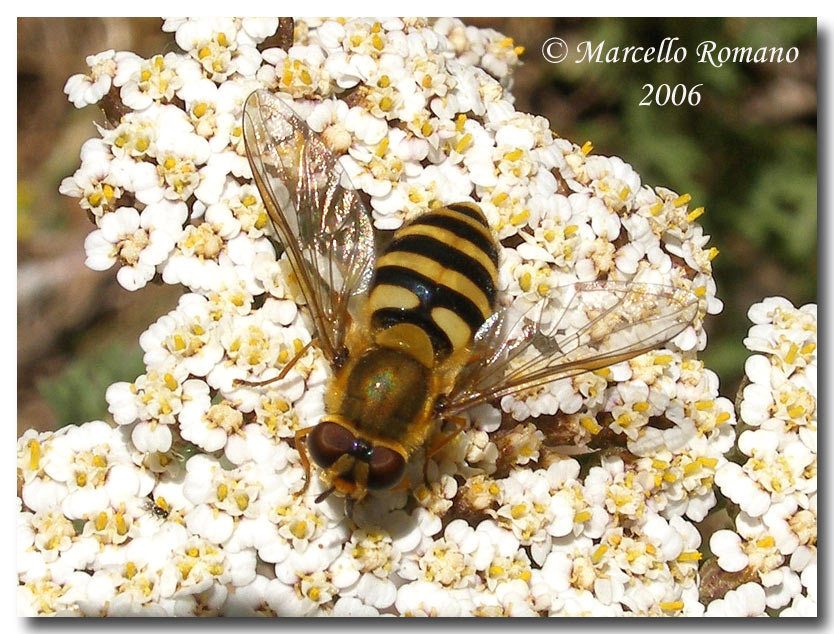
xmin=38 ymin=341 xmax=144 ymax=427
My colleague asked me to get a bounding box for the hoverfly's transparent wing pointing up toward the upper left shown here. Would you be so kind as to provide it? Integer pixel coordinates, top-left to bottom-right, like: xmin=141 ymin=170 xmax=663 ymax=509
xmin=243 ymin=90 xmax=374 ymax=361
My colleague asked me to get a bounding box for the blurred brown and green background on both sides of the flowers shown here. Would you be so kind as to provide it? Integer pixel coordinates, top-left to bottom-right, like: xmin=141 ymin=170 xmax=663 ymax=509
xmin=17 ymin=18 xmax=817 ymax=435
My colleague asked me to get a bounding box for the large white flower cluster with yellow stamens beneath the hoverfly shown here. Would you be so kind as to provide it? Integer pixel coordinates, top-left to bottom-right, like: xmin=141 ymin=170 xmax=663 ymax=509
xmin=18 ymin=14 xmax=792 ymax=616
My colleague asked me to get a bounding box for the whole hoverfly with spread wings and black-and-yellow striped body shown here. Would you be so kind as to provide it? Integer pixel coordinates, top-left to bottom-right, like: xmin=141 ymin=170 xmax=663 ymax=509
xmin=243 ymin=91 xmax=698 ymax=503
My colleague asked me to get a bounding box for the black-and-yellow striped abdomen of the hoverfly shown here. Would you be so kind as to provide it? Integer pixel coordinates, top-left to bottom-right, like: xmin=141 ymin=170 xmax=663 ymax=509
xmin=369 ymin=203 xmax=498 ymax=360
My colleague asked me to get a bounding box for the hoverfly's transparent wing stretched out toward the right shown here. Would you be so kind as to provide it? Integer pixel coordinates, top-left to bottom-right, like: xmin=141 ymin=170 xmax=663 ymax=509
xmin=444 ymin=282 xmax=698 ymax=414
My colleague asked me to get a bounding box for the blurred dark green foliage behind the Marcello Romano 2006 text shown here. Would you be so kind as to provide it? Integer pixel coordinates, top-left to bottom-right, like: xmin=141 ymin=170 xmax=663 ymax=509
xmin=546 ymin=18 xmax=817 ymax=392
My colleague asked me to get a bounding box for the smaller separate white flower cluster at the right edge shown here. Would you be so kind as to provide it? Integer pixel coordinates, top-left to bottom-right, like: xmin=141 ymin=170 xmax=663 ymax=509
xmin=707 ymin=297 xmax=817 ymax=616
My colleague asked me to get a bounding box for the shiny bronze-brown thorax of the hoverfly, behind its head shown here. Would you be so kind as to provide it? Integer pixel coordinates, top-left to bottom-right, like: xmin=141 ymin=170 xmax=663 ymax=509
xmin=339 ymin=348 xmax=429 ymax=441
